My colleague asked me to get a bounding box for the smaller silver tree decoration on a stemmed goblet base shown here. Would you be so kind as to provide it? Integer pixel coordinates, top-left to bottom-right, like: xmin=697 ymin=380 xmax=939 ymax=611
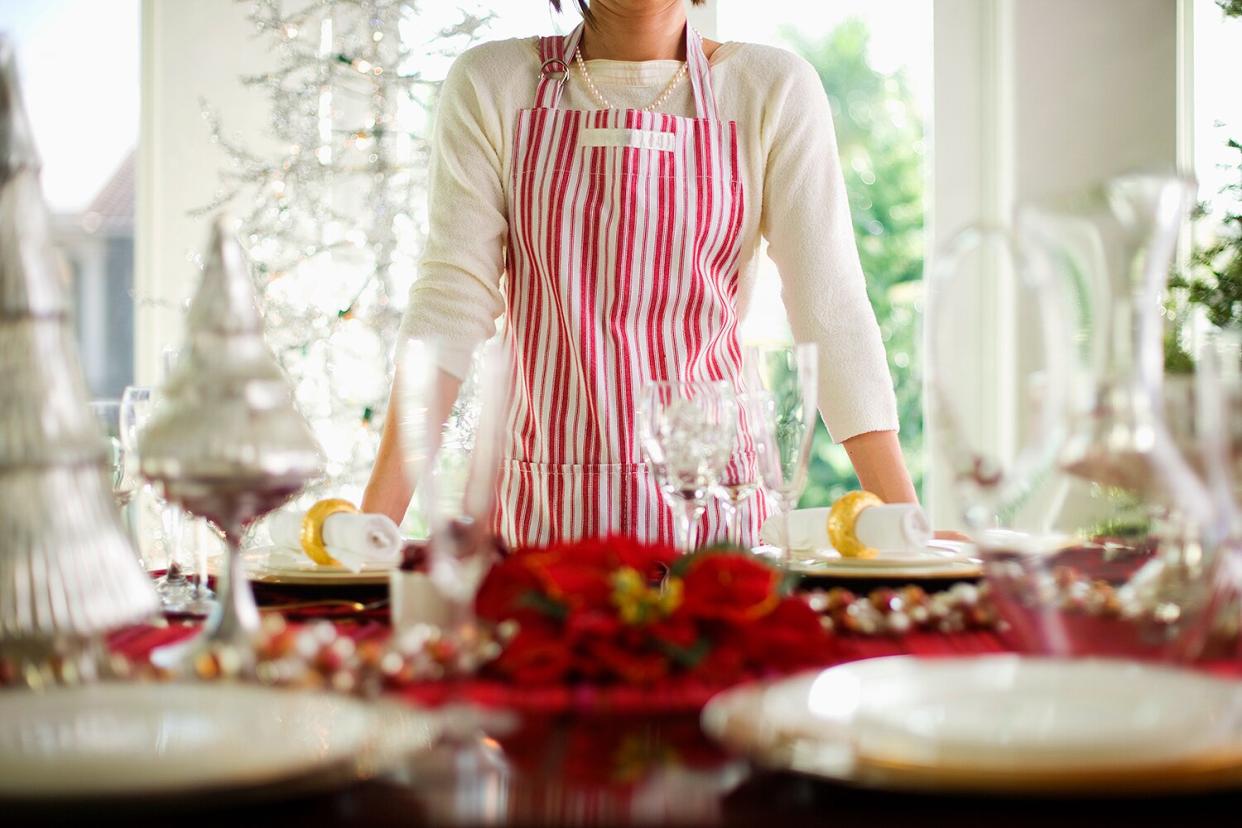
xmin=138 ymin=216 xmax=323 ymax=672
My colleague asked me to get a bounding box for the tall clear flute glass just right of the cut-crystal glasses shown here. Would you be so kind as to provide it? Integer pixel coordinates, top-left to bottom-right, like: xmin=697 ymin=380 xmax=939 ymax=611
xmin=744 ymin=344 xmax=818 ymax=571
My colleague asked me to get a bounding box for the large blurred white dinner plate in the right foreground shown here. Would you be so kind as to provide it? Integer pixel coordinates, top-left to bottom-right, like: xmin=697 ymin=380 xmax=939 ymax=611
xmin=703 ymin=655 xmax=1242 ymax=794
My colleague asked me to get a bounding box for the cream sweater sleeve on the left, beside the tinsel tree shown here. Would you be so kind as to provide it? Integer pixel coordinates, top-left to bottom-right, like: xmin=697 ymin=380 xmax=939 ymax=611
xmin=401 ymin=50 xmax=508 ymax=376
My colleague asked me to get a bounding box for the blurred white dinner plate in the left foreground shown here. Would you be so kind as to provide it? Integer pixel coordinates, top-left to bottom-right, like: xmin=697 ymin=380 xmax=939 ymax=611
xmin=0 ymin=683 xmax=436 ymax=801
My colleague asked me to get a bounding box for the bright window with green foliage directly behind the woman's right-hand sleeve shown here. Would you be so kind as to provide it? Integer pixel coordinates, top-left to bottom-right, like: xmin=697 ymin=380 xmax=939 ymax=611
xmin=715 ymin=0 xmax=932 ymax=505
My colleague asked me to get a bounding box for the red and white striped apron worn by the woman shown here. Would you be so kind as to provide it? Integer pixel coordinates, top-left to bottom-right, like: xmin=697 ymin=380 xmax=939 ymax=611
xmin=498 ymin=26 xmax=764 ymax=545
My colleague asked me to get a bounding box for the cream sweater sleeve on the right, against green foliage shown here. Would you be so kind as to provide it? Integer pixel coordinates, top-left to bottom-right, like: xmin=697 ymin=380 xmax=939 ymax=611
xmin=760 ymin=54 xmax=898 ymax=442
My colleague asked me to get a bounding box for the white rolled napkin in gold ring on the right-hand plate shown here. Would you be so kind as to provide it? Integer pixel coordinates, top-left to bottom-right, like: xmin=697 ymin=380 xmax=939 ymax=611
xmin=759 ymin=503 xmax=932 ymax=554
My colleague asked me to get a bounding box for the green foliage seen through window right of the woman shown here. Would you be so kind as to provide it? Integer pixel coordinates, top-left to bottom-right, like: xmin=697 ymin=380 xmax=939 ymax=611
xmin=784 ymin=20 xmax=924 ymax=506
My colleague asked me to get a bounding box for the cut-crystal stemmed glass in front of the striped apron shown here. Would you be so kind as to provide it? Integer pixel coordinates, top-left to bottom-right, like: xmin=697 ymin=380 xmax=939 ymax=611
xmin=638 ymin=381 xmax=738 ymax=552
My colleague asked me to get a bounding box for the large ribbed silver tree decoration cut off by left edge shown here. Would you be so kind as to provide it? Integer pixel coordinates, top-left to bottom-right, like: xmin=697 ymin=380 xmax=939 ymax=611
xmin=0 ymin=36 xmax=159 ymax=684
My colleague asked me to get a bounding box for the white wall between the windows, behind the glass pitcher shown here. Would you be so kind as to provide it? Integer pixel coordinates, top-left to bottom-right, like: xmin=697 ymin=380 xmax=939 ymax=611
xmin=928 ymin=0 xmax=1180 ymax=526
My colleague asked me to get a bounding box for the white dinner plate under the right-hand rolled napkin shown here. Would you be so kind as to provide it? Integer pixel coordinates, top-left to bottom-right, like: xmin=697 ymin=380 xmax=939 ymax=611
xmin=789 ymin=540 xmax=982 ymax=580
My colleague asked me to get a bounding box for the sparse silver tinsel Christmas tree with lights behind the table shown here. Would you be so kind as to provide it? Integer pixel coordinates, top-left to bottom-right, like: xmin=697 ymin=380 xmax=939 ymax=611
xmin=194 ymin=0 xmax=488 ymax=492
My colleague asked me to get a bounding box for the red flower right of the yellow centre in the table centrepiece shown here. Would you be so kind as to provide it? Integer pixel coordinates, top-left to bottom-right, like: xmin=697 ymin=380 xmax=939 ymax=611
xmin=681 ymin=552 xmax=780 ymax=624
